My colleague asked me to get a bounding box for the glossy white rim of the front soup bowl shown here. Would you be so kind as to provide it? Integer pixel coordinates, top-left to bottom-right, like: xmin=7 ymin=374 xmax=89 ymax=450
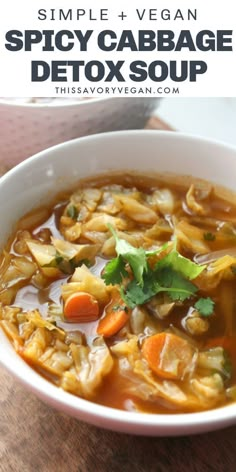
xmin=0 ymin=130 xmax=236 ymax=436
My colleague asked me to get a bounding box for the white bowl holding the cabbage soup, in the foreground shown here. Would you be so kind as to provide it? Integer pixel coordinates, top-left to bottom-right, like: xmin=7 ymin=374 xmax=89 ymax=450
xmin=0 ymin=131 xmax=236 ymax=436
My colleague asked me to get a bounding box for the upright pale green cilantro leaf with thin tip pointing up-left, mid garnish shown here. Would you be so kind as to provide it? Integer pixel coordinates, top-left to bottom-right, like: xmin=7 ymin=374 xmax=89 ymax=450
xmin=107 ymin=224 xmax=147 ymax=285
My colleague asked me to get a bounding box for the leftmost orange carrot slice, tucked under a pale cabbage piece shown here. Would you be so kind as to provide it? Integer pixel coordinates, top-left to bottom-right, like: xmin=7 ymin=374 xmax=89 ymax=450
xmin=64 ymin=292 xmax=99 ymax=323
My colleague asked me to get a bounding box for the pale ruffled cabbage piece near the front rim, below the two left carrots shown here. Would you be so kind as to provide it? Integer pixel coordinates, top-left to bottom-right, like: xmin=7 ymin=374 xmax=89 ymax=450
xmin=70 ymin=338 xmax=114 ymax=398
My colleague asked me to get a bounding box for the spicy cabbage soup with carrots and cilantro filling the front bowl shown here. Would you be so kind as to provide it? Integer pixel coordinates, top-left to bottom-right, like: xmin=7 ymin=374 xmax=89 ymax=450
xmin=0 ymin=173 xmax=236 ymax=413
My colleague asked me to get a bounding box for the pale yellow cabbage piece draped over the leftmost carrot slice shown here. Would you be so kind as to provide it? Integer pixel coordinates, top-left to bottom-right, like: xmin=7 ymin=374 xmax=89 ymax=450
xmin=61 ymin=265 xmax=109 ymax=306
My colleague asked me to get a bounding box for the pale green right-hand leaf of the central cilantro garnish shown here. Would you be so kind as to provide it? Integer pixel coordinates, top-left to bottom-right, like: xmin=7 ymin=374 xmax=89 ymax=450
xmin=156 ymin=249 xmax=206 ymax=280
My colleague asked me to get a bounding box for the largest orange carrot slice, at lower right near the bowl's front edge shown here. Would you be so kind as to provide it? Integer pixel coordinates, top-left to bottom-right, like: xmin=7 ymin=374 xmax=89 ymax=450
xmin=142 ymin=332 xmax=193 ymax=379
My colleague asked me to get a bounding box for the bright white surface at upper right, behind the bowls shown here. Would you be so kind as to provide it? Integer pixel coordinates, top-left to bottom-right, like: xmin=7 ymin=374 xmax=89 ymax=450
xmin=157 ymin=98 xmax=236 ymax=146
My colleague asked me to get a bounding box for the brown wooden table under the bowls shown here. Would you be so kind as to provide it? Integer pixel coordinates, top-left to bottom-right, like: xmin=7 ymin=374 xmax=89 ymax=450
xmin=0 ymin=118 xmax=236 ymax=472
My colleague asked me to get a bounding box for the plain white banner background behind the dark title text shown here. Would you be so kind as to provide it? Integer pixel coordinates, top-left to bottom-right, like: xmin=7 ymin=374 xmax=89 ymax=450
xmin=0 ymin=0 xmax=236 ymax=97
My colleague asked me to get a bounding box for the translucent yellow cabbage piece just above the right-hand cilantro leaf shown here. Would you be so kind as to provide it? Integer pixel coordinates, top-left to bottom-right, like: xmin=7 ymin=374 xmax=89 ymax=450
xmin=175 ymin=220 xmax=209 ymax=254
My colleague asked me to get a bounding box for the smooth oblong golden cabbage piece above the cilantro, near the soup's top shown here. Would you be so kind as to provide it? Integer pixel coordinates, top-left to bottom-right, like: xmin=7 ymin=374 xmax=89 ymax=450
xmin=114 ymin=195 xmax=157 ymax=224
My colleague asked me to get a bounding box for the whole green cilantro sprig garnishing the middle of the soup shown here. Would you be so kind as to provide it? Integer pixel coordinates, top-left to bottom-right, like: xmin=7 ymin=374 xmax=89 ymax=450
xmin=102 ymin=225 xmax=210 ymax=310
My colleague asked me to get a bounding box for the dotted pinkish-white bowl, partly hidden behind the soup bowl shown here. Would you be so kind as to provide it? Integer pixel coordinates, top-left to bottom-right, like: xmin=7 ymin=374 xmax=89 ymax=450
xmin=0 ymin=97 xmax=159 ymax=167
